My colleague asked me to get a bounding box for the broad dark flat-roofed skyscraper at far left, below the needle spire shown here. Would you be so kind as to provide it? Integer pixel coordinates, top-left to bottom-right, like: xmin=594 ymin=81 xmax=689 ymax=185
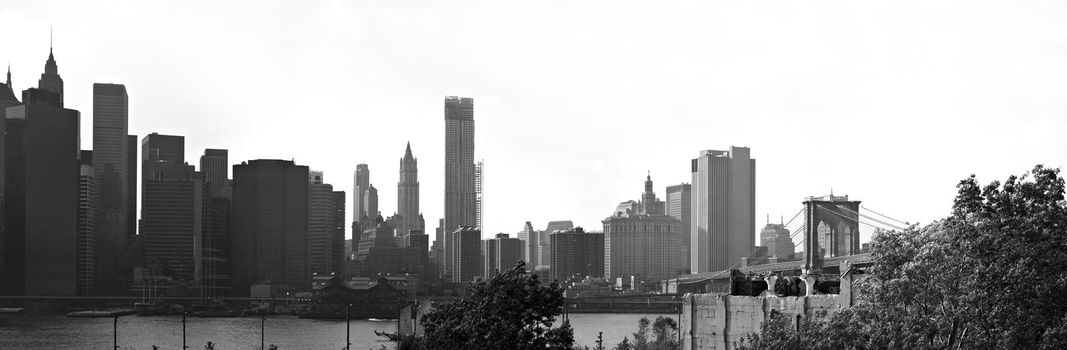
xmin=0 ymin=96 xmax=80 ymax=296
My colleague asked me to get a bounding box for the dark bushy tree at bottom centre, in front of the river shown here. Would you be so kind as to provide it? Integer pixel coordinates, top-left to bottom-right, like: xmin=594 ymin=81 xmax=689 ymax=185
xmin=398 ymin=263 xmax=574 ymax=349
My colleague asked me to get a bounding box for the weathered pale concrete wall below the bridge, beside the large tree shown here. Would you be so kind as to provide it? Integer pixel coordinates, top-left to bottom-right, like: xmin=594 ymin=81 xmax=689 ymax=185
xmin=679 ymin=293 xmax=849 ymax=350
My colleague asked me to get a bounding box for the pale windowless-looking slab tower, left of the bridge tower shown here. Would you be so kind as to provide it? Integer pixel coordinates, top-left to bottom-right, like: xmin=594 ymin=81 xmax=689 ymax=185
xmin=690 ymin=147 xmax=755 ymax=273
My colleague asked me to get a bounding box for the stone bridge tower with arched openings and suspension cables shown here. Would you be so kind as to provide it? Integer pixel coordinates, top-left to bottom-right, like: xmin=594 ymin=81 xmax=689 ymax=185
xmin=803 ymin=194 xmax=860 ymax=275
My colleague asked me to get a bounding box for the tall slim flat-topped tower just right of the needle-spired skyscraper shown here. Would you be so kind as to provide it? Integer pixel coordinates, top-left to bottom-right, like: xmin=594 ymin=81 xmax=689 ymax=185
xmin=92 ymin=82 xmax=128 ymax=295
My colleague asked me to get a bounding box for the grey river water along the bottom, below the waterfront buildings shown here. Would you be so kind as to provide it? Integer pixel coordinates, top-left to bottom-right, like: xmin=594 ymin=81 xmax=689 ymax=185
xmin=0 ymin=314 xmax=676 ymax=350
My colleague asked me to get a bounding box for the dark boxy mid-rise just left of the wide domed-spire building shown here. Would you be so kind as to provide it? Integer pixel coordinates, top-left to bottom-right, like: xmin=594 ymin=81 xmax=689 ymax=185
xmin=550 ymin=227 xmax=604 ymax=281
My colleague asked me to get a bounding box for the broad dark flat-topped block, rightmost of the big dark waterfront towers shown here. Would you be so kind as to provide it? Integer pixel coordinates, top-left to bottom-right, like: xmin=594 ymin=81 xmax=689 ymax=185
xmin=232 ymin=159 xmax=310 ymax=297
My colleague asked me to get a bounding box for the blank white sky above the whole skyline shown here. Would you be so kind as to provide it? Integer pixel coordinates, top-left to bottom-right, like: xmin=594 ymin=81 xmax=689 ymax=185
xmin=0 ymin=0 xmax=1067 ymax=246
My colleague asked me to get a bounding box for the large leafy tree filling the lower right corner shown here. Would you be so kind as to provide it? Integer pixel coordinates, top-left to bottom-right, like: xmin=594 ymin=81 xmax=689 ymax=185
xmin=743 ymin=165 xmax=1067 ymax=349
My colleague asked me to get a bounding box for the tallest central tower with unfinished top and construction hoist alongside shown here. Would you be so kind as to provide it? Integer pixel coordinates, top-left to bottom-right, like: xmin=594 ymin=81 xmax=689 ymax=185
xmin=444 ymin=96 xmax=481 ymax=277
